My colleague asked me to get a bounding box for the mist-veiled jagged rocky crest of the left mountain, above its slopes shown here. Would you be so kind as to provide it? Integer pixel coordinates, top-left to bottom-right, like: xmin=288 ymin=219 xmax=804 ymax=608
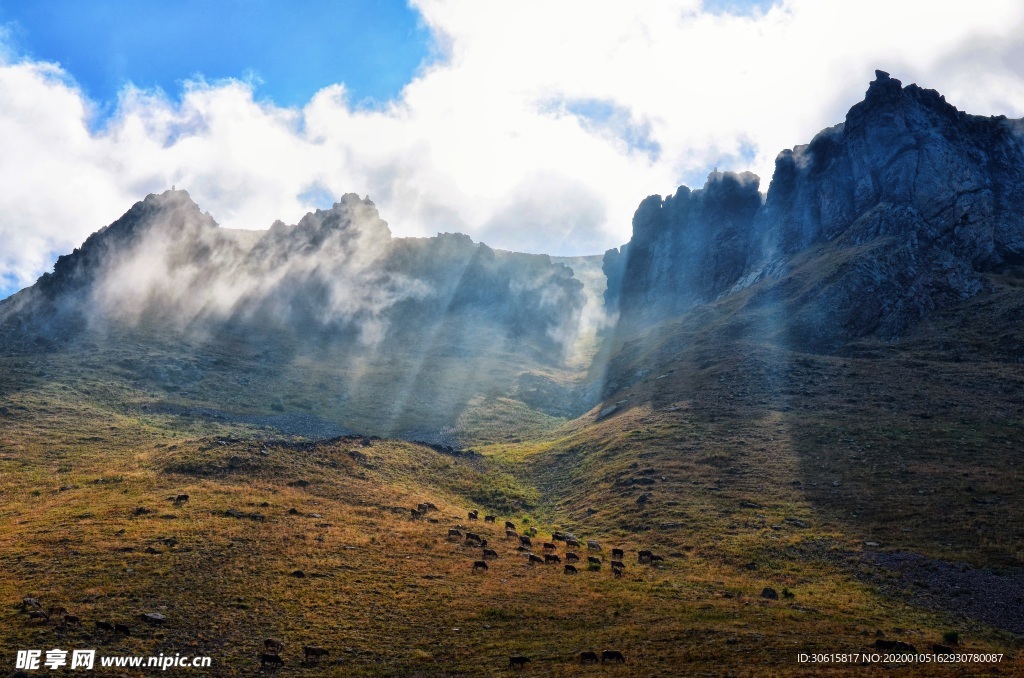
xmin=0 ymin=190 xmax=585 ymax=361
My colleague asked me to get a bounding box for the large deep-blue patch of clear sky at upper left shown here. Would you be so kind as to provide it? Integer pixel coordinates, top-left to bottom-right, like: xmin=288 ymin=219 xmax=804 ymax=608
xmin=0 ymin=0 xmax=431 ymax=113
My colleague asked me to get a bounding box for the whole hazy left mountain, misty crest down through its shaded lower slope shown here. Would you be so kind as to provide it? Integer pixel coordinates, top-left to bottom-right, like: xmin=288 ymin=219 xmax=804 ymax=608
xmin=0 ymin=190 xmax=586 ymax=440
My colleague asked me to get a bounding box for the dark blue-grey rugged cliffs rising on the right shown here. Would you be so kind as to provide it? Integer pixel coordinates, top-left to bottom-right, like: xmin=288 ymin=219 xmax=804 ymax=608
xmin=605 ymin=71 xmax=1024 ymax=350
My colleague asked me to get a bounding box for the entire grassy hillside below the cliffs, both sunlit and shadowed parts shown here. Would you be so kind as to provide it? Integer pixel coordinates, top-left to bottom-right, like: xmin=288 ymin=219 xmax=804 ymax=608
xmin=0 ymin=276 xmax=1024 ymax=676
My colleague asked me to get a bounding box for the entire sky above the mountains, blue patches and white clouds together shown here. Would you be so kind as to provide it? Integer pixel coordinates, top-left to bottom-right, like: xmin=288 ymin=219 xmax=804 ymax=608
xmin=0 ymin=0 xmax=1024 ymax=297
